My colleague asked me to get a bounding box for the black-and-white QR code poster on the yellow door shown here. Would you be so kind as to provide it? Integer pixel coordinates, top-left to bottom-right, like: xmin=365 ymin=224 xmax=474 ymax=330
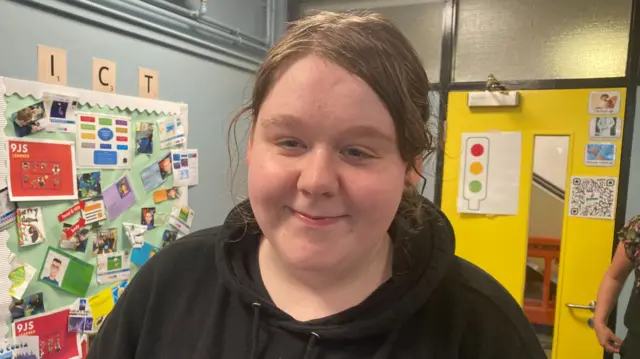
xmin=569 ymin=176 xmax=618 ymax=219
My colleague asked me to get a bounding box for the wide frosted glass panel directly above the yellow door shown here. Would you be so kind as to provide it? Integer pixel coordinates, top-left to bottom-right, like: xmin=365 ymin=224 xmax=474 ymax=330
xmin=454 ymin=0 xmax=632 ymax=82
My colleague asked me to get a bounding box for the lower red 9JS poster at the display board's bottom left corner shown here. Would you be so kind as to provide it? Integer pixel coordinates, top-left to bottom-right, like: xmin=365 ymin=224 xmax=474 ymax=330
xmin=13 ymin=309 xmax=82 ymax=359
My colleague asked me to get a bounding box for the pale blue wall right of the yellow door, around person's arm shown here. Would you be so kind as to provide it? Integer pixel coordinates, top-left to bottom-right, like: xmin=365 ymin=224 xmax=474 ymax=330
xmin=616 ymin=88 xmax=640 ymax=358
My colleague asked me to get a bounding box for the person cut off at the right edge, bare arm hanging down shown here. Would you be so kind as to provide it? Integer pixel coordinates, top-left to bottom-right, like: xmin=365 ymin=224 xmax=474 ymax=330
xmin=594 ymin=216 xmax=640 ymax=359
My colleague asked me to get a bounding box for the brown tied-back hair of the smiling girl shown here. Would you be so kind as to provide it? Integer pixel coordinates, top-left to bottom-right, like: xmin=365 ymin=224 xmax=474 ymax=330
xmin=227 ymin=12 xmax=435 ymax=228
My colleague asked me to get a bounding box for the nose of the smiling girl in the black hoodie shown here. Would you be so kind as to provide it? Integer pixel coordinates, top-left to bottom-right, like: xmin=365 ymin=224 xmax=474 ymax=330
xmin=298 ymin=150 xmax=339 ymax=197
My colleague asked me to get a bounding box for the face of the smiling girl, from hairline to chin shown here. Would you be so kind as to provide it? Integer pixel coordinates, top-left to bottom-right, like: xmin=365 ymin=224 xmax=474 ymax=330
xmin=247 ymin=56 xmax=407 ymax=270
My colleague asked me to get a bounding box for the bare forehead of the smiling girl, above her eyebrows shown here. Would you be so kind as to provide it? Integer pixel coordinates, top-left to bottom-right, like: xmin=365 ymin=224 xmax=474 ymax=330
xmin=259 ymin=56 xmax=395 ymax=135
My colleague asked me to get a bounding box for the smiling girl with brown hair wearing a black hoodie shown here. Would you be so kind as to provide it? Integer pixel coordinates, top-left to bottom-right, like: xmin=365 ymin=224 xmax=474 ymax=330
xmin=89 ymin=13 xmax=545 ymax=359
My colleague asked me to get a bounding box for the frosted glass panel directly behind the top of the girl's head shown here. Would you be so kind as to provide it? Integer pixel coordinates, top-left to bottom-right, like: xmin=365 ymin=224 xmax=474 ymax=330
xmin=301 ymin=0 xmax=444 ymax=83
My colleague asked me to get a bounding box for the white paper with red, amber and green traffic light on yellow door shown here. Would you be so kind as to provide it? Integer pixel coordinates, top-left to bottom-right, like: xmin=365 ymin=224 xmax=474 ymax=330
xmin=458 ymin=132 xmax=522 ymax=215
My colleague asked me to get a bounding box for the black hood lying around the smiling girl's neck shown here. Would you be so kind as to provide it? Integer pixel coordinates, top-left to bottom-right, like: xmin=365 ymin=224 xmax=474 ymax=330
xmin=216 ymin=199 xmax=455 ymax=341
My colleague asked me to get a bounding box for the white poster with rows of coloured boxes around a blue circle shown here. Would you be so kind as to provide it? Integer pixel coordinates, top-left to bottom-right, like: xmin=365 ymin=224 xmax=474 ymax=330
xmin=76 ymin=112 xmax=132 ymax=169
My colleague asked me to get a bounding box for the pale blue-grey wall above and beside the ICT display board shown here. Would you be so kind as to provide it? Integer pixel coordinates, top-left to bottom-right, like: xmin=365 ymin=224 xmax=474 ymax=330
xmin=0 ymin=0 xmax=286 ymax=229
